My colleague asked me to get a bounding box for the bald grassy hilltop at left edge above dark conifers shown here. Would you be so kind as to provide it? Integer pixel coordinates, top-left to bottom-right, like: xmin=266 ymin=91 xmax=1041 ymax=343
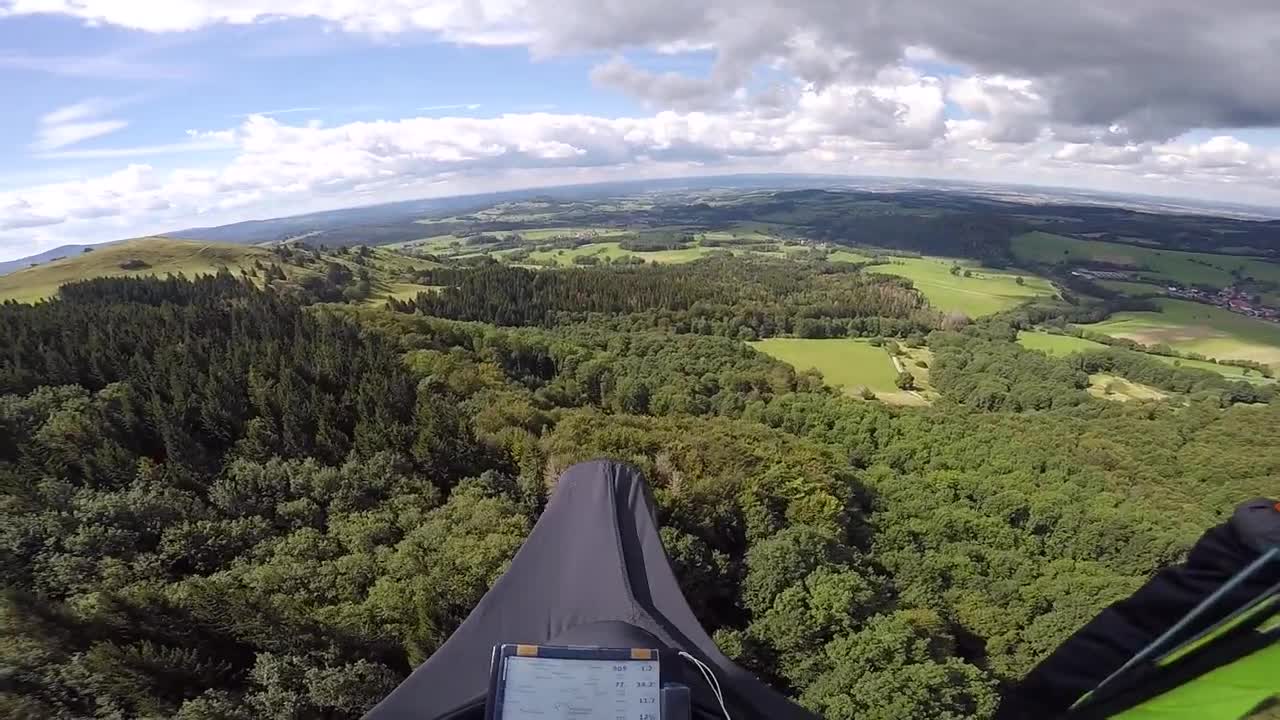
xmin=0 ymin=237 xmax=274 ymax=302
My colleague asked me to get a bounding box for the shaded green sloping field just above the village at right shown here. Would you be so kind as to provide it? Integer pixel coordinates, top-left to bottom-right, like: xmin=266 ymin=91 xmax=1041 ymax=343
xmin=1012 ymin=232 xmax=1280 ymax=287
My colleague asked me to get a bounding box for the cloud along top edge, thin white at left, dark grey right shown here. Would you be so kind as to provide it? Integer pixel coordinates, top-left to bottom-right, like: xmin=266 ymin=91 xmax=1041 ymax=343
xmin=10 ymin=0 xmax=1280 ymax=145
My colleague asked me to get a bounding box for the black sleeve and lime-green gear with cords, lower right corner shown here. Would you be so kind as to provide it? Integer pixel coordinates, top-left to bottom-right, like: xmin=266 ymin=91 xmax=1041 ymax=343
xmin=996 ymin=498 xmax=1280 ymax=720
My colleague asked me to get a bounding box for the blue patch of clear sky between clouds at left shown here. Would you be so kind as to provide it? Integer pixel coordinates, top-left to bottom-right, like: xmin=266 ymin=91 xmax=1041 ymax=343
xmin=0 ymin=17 xmax=640 ymax=176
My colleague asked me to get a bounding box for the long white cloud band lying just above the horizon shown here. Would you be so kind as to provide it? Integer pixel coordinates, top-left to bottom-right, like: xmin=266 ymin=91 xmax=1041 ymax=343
xmin=0 ymin=82 xmax=1280 ymax=256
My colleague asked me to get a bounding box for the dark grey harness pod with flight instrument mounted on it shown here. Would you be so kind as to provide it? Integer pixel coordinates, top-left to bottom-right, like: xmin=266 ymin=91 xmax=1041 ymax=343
xmin=366 ymin=460 xmax=819 ymax=720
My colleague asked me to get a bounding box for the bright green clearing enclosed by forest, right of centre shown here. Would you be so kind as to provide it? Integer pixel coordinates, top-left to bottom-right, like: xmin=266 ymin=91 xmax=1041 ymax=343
xmin=750 ymin=337 xmax=899 ymax=395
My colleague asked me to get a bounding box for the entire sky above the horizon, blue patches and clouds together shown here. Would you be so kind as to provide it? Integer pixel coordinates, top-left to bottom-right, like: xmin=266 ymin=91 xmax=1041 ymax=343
xmin=0 ymin=0 xmax=1280 ymax=260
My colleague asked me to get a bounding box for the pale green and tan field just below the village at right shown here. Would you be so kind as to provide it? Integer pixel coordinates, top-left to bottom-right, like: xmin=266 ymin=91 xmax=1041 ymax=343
xmin=1082 ymin=299 xmax=1280 ymax=365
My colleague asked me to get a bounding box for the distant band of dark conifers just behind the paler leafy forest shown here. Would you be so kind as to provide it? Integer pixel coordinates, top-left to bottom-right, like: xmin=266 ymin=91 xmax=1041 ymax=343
xmin=404 ymin=256 xmax=940 ymax=340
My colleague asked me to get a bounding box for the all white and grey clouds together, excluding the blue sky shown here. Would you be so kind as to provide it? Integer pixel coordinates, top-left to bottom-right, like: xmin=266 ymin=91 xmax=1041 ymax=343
xmin=0 ymin=0 xmax=1280 ymax=256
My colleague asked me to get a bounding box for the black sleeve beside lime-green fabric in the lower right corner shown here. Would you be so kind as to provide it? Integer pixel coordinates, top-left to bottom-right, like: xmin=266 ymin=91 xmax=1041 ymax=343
xmin=996 ymin=501 xmax=1280 ymax=720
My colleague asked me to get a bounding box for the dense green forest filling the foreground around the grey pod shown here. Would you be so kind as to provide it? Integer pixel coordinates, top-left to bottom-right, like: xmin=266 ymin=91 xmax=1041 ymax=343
xmin=0 ymin=259 xmax=1280 ymax=720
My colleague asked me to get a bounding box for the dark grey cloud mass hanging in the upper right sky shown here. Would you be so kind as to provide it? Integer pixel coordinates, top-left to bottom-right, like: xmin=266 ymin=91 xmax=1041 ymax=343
xmin=536 ymin=0 xmax=1280 ymax=142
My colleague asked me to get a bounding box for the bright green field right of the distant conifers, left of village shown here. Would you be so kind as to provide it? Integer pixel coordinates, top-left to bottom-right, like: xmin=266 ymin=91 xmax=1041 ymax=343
xmin=869 ymin=258 xmax=1057 ymax=318
